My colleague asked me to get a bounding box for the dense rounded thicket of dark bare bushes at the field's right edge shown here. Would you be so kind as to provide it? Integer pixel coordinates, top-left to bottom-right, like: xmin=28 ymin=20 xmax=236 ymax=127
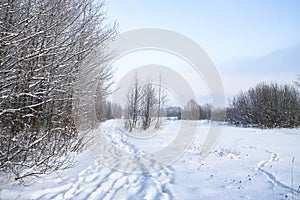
xmin=226 ymin=83 xmax=300 ymax=128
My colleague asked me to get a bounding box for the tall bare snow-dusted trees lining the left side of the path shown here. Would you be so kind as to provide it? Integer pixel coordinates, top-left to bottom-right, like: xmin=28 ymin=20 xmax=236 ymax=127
xmin=0 ymin=0 xmax=115 ymax=179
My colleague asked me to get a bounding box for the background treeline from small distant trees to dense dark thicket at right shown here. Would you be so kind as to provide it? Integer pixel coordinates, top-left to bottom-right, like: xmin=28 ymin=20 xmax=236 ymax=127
xmin=166 ymin=80 xmax=300 ymax=128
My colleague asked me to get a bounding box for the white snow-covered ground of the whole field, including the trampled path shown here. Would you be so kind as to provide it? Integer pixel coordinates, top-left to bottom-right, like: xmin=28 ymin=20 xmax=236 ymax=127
xmin=0 ymin=120 xmax=300 ymax=200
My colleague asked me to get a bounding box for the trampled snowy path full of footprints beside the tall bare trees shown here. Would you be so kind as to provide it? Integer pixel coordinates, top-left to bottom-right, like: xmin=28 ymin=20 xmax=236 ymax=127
xmin=0 ymin=123 xmax=174 ymax=200
